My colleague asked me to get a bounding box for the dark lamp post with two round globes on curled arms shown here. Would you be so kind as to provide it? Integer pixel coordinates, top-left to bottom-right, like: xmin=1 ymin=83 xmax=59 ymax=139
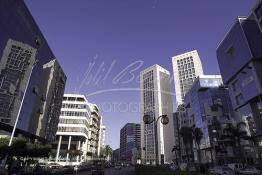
xmin=143 ymin=114 xmax=169 ymax=165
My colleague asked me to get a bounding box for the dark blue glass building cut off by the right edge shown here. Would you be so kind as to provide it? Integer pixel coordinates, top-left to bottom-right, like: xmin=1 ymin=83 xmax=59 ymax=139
xmin=217 ymin=1 xmax=262 ymax=161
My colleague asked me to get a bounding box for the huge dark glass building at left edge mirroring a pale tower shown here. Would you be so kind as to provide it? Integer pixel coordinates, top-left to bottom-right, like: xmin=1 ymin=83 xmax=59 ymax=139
xmin=0 ymin=0 xmax=66 ymax=141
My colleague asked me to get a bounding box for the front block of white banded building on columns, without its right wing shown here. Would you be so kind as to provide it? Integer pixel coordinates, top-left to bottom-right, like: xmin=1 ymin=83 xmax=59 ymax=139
xmin=53 ymin=94 xmax=91 ymax=164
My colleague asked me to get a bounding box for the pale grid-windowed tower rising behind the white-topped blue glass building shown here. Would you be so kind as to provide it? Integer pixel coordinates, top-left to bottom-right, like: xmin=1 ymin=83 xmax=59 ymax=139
xmin=172 ymin=50 xmax=204 ymax=107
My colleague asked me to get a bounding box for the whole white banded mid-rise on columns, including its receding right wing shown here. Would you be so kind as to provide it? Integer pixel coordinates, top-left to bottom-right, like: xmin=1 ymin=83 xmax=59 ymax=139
xmin=53 ymin=94 xmax=100 ymax=164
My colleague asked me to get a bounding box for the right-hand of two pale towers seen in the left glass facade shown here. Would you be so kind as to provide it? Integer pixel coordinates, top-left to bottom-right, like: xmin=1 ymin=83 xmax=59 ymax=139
xmin=29 ymin=60 xmax=66 ymax=142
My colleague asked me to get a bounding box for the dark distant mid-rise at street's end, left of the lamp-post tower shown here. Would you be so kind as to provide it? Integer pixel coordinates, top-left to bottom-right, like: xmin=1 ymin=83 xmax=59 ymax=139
xmin=120 ymin=123 xmax=141 ymax=163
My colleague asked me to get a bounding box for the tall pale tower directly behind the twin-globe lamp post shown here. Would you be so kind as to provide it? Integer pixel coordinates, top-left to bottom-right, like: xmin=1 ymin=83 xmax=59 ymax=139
xmin=140 ymin=65 xmax=175 ymax=164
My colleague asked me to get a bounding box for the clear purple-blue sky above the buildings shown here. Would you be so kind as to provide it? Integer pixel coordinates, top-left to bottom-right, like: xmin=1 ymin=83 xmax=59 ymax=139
xmin=25 ymin=0 xmax=256 ymax=149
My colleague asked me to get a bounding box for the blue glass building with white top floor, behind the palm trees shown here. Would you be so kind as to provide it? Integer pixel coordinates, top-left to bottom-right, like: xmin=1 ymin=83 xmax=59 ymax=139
xmin=185 ymin=75 xmax=235 ymax=163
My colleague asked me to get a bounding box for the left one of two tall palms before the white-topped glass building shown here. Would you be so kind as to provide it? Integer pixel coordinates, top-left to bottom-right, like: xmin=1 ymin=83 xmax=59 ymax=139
xmin=179 ymin=126 xmax=193 ymax=162
